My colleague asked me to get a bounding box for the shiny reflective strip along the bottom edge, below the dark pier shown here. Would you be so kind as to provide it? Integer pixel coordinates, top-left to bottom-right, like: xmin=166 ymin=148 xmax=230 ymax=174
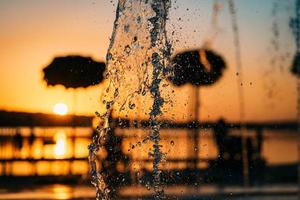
xmin=0 ymin=184 xmax=298 ymax=200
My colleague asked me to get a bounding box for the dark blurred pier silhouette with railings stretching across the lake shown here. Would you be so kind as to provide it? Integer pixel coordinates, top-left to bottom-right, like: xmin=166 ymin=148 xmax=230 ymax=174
xmin=0 ymin=112 xmax=297 ymax=188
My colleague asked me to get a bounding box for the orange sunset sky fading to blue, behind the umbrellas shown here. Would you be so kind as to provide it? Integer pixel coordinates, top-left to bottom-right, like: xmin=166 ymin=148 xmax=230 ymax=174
xmin=0 ymin=0 xmax=297 ymax=121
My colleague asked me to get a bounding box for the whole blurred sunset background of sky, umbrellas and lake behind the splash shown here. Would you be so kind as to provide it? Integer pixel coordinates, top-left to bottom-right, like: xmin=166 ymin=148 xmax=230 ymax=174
xmin=0 ymin=0 xmax=300 ymax=199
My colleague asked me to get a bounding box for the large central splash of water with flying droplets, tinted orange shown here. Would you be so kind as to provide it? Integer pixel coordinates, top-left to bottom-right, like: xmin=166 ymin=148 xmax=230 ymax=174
xmin=89 ymin=0 xmax=171 ymax=199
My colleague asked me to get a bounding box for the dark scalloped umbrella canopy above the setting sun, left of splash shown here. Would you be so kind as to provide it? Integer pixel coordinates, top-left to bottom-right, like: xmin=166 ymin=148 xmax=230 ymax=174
xmin=43 ymin=55 xmax=105 ymax=89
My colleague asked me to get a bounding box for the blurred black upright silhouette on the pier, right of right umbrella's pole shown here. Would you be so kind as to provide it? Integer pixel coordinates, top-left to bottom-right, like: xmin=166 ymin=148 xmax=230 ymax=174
xmin=209 ymin=119 xmax=265 ymax=184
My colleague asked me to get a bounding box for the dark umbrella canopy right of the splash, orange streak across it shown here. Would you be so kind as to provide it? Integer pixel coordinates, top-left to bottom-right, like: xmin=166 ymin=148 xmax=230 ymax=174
xmin=169 ymin=49 xmax=226 ymax=86
